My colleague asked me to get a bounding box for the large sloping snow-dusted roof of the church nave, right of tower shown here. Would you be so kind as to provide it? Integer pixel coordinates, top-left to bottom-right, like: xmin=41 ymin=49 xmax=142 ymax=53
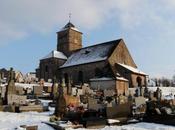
xmin=60 ymin=39 xmax=121 ymax=68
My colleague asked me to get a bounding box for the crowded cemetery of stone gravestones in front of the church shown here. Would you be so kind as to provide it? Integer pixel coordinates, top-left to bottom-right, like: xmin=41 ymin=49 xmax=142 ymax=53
xmin=0 ymin=69 xmax=175 ymax=129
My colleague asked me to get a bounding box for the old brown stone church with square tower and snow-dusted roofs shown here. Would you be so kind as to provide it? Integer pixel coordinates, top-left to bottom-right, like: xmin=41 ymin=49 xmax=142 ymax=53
xmin=36 ymin=22 xmax=147 ymax=88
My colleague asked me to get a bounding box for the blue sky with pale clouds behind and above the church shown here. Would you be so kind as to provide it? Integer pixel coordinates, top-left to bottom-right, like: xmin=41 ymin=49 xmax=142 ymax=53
xmin=0 ymin=0 xmax=175 ymax=78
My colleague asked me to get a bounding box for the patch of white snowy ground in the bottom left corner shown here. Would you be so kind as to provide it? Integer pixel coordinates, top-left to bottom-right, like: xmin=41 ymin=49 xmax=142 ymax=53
xmin=0 ymin=107 xmax=53 ymax=130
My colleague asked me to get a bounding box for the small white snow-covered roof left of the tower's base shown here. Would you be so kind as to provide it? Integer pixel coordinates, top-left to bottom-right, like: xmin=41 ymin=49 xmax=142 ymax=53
xmin=42 ymin=50 xmax=67 ymax=60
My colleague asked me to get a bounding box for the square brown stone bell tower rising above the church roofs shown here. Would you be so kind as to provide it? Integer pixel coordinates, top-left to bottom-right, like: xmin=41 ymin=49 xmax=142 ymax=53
xmin=57 ymin=21 xmax=82 ymax=57
